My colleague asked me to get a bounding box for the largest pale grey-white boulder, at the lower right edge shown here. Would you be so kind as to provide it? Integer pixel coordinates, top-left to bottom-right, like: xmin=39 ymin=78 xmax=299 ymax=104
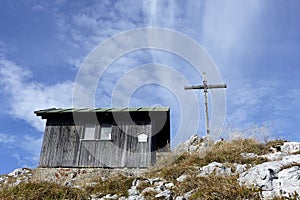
xmin=238 ymin=155 xmax=300 ymax=198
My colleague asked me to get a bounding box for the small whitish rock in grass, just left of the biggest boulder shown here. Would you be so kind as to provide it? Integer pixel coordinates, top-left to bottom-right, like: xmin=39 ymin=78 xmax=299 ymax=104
xmin=198 ymin=162 xmax=233 ymax=176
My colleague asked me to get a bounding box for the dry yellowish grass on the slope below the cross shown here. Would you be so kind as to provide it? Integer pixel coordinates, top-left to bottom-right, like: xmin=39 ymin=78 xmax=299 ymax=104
xmin=146 ymin=139 xmax=272 ymax=181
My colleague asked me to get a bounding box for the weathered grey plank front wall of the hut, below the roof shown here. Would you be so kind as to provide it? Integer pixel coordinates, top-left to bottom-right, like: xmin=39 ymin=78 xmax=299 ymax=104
xmin=39 ymin=120 xmax=155 ymax=168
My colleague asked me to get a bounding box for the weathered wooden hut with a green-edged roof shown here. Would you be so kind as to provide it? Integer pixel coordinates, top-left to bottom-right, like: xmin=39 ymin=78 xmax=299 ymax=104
xmin=34 ymin=108 xmax=170 ymax=168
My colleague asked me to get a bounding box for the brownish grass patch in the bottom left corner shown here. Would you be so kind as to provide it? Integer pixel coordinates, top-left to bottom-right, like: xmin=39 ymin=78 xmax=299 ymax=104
xmin=0 ymin=182 xmax=88 ymax=200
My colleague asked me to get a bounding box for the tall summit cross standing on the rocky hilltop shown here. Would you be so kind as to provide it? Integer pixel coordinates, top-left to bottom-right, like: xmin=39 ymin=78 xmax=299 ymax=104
xmin=184 ymin=72 xmax=227 ymax=136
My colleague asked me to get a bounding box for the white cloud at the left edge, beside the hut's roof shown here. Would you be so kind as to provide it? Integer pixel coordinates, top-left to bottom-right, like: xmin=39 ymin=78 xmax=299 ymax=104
xmin=0 ymin=57 xmax=73 ymax=132
